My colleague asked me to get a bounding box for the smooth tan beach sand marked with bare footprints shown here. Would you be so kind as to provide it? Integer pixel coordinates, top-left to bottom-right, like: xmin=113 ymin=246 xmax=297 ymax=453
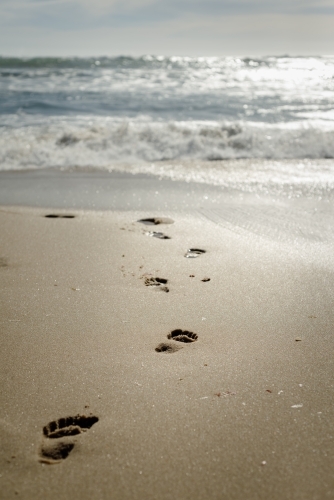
xmin=0 ymin=173 xmax=334 ymax=500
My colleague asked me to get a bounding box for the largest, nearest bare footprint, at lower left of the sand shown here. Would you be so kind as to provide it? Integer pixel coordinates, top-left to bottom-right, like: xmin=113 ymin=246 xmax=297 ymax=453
xmin=39 ymin=415 xmax=99 ymax=464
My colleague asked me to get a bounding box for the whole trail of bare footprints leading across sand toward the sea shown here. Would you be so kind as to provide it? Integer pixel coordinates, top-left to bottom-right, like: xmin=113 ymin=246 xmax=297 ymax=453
xmin=39 ymin=214 xmax=209 ymax=464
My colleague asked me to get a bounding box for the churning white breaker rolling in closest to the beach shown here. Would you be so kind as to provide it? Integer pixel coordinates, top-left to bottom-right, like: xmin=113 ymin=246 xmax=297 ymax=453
xmin=0 ymin=117 xmax=334 ymax=169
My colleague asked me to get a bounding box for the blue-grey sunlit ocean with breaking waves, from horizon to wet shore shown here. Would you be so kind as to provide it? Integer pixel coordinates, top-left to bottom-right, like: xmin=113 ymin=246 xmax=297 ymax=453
xmin=0 ymin=56 xmax=334 ymax=194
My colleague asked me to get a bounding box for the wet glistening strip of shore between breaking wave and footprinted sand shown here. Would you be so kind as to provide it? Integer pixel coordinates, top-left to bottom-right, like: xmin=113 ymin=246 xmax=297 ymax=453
xmin=0 ymin=158 xmax=334 ymax=204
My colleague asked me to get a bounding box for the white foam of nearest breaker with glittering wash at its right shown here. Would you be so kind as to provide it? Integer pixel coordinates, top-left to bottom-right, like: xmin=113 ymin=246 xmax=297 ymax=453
xmin=0 ymin=117 xmax=334 ymax=196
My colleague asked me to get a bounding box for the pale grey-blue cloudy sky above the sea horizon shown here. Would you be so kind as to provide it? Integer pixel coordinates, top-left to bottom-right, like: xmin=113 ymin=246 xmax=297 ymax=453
xmin=0 ymin=0 xmax=334 ymax=57
